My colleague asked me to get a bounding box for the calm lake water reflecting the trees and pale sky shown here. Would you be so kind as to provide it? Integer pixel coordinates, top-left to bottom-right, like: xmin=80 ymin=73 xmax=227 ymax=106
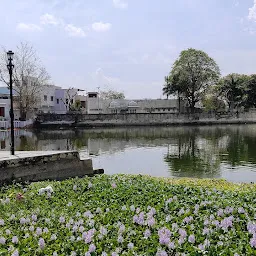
xmin=0 ymin=125 xmax=256 ymax=182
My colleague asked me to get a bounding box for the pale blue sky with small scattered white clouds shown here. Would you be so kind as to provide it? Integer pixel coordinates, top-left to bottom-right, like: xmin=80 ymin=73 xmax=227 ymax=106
xmin=0 ymin=0 xmax=256 ymax=99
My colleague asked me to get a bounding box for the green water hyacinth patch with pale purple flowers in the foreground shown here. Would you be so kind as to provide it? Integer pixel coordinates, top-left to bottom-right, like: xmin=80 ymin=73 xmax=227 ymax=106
xmin=0 ymin=175 xmax=256 ymax=256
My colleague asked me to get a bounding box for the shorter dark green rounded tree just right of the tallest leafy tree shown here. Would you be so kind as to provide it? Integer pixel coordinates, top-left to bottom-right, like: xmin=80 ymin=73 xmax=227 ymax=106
xmin=218 ymin=73 xmax=249 ymax=111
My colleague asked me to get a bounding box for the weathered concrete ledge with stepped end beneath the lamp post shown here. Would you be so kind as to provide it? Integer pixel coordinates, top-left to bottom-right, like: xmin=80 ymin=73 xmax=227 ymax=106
xmin=0 ymin=151 xmax=94 ymax=184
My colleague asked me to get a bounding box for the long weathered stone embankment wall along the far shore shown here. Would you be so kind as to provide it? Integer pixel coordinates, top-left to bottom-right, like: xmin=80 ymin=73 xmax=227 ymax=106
xmin=35 ymin=112 xmax=256 ymax=128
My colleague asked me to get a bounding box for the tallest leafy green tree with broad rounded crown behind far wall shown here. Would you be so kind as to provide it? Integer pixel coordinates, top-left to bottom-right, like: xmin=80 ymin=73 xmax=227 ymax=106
xmin=164 ymin=48 xmax=220 ymax=113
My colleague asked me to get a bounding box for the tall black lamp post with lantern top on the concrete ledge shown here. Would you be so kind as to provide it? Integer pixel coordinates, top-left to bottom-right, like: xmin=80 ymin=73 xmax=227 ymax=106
xmin=7 ymin=51 xmax=14 ymax=155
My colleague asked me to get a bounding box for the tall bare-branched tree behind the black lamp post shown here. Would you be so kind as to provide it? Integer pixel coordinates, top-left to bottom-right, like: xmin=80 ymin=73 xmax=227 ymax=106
xmin=0 ymin=42 xmax=50 ymax=119
